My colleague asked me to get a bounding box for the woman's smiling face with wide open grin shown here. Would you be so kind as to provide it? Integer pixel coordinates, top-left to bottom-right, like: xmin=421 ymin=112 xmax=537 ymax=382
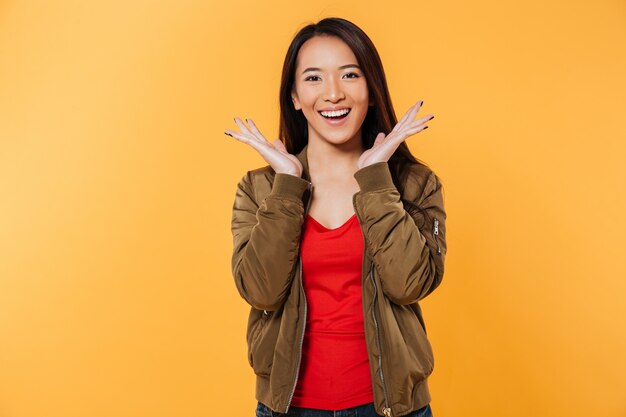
xmin=291 ymin=36 xmax=373 ymax=145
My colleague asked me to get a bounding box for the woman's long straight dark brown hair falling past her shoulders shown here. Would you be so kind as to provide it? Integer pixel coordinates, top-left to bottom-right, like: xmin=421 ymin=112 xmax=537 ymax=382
xmin=278 ymin=17 xmax=439 ymax=218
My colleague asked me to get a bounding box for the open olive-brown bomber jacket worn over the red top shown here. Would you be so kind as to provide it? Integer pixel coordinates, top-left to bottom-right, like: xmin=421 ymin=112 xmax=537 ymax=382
xmin=231 ymin=145 xmax=447 ymax=417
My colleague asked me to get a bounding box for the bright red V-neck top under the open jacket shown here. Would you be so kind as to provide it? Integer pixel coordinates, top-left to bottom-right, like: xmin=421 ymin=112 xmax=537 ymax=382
xmin=291 ymin=214 xmax=374 ymax=410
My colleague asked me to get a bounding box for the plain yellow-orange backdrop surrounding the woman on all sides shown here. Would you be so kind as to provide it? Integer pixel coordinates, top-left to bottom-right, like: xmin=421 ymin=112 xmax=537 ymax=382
xmin=0 ymin=0 xmax=626 ymax=417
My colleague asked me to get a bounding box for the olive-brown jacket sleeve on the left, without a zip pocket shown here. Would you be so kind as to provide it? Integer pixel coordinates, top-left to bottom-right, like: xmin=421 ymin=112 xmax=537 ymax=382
xmin=231 ymin=171 xmax=309 ymax=310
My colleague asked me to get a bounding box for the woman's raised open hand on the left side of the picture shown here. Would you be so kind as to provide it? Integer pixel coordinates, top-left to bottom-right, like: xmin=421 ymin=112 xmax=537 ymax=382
xmin=224 ymin=117 xmax=302 ymax=177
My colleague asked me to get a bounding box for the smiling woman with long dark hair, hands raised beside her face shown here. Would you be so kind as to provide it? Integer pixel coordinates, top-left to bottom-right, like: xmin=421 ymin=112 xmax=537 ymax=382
xmin=225 ymin=18 xmax=446 ymax=417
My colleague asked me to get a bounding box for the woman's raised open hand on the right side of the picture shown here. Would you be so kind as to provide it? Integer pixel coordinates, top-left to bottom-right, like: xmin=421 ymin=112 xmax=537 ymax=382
xmin=357 ymin=100 xmax=435 ymax=169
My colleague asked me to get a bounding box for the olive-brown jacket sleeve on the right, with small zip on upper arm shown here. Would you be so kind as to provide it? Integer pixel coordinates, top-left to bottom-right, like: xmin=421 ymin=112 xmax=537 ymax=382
xmin=354 ymin=162 xmax=447 ymax=304
